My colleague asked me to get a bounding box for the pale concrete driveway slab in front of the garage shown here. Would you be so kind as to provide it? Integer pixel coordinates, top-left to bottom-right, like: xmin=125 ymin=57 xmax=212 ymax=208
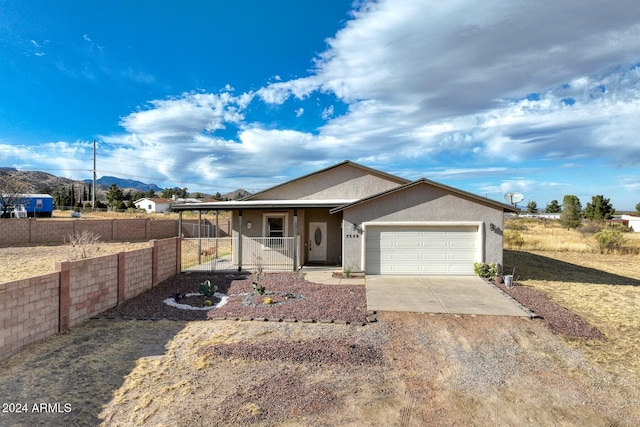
xmin=366 ymin=276 xmax=531 ymax=317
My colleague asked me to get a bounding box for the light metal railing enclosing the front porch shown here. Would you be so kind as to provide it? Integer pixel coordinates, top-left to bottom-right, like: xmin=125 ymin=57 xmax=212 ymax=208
xmin=181 ymin=237 xmax=300 ymax=271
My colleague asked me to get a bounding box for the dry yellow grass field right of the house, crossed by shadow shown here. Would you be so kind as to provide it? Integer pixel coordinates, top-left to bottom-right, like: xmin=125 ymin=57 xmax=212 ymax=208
xmin=504 ymin=220 xmax=640 ymax=377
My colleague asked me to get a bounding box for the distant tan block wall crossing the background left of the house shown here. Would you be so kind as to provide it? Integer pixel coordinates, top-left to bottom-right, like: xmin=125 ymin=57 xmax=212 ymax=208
xmin=0 ymin=218 xmax=178 ymax=245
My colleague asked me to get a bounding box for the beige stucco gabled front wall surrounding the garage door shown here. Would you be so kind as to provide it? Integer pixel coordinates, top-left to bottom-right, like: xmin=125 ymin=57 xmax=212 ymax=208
xmin=343 ymin=183 xmax=504 ymax=271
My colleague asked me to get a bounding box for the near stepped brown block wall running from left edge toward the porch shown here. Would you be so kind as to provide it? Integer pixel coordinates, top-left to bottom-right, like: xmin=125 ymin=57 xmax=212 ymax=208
xmin=0 ymin=237 xmax=181 ymax=358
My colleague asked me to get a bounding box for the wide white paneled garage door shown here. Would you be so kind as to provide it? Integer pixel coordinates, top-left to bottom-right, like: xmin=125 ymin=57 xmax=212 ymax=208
xmin=365 ymin=226 xmax=480 ymax=275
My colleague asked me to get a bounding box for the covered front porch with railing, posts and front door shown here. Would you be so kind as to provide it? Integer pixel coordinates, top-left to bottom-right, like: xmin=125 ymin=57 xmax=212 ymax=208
xmin=174 ymin=200 xmax=344 ymax=271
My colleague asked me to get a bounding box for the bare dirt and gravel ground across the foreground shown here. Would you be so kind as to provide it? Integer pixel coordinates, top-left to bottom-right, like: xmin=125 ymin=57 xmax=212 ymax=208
xmin=0 ymin=313 xmax=640 ymax=426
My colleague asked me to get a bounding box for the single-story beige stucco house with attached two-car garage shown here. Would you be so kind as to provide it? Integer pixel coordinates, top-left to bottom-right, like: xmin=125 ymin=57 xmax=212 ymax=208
xmin=173 ymin=160 xmax=516 ymax=275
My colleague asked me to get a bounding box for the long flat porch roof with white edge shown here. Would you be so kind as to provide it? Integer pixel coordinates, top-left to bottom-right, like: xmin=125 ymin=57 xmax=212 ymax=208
xmin=171 ymin=199 xmax=356 ymax=211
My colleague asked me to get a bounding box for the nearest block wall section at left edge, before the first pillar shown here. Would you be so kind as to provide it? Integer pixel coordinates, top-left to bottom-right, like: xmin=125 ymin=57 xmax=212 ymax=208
xmin=0 ymin=273 xmax=60 ymax=357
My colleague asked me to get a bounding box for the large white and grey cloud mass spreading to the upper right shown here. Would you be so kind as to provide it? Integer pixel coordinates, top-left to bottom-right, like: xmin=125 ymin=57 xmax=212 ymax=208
xmin=40 ymin=0 xmax=640 ymax=207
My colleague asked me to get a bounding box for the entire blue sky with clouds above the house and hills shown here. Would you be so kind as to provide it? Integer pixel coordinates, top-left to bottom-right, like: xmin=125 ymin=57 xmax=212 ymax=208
xmin=0 ymin=0 xmax=640 ymax=210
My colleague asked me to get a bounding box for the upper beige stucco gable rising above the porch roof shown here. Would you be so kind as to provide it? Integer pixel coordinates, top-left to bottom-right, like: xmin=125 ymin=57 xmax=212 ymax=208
xmin=252 ymin=164 xmax=406 ymax=200
